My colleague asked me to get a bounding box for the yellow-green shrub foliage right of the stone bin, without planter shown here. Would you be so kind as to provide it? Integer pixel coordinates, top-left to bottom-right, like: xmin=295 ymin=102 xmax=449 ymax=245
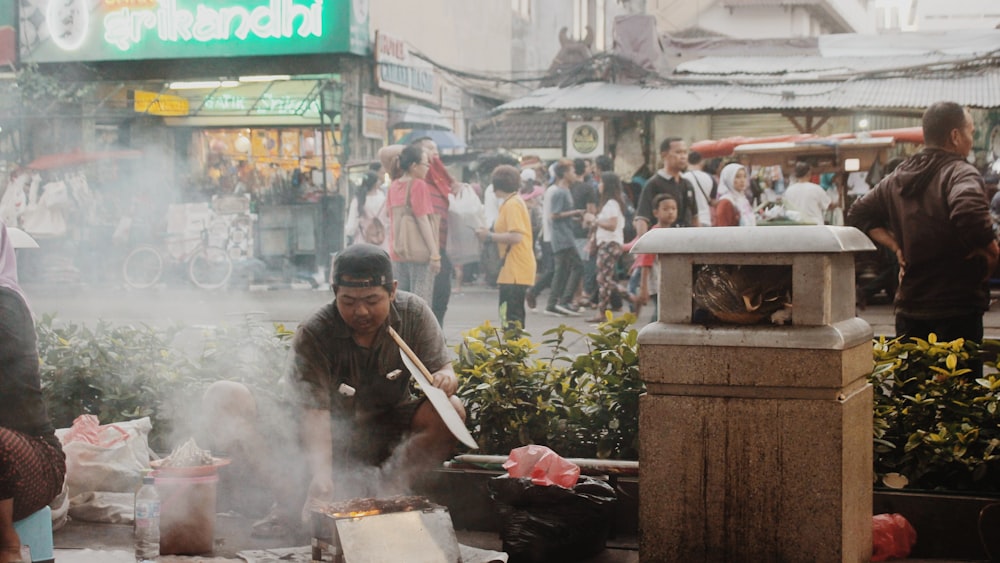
xmin=869 ymin=335 xmax=1000 ymax=492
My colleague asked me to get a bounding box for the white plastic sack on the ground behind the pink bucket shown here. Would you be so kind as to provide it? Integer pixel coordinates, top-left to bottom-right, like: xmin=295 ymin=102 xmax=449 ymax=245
xmin=56 ymin=414 xmax=153 ymax=498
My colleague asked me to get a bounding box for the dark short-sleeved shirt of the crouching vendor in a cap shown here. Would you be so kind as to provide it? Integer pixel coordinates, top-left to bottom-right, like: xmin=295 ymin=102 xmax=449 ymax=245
xmin=288 ymin=291 xmax=451 ymax=418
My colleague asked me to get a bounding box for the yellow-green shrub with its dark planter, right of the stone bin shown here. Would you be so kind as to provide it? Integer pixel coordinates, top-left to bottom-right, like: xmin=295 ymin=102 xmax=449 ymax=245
xmin=869 ymin=335 xmax=1000 ymax=559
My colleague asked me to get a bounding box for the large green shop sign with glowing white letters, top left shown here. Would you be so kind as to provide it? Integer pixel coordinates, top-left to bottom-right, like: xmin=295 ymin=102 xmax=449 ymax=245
xmin=20 ymin=0 xmax=369 ymax=62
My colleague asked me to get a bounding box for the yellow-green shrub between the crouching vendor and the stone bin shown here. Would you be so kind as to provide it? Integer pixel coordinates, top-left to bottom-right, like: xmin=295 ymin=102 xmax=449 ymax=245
xmin=455 ymin=315 xmax=645 ymax=459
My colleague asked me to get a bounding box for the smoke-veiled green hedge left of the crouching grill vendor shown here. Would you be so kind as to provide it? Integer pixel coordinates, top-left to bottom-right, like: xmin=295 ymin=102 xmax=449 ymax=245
xmin=35 ymin=315 xmax=292 ymax=451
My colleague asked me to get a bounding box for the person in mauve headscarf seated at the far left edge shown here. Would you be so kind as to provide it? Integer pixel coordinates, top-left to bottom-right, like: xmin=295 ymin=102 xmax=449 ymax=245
xmin=0 ymin=221 xmax=66 ymax=563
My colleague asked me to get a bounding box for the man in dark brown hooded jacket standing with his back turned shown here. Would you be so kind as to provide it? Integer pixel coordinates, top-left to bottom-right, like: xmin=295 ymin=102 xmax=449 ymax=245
xmin=847 ymin=102 xmax=998 ymax=342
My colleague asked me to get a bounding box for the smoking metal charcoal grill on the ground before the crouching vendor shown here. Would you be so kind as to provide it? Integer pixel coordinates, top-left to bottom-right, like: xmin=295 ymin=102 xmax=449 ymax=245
xmin=310 ymin=496 xmax=462 ymax=563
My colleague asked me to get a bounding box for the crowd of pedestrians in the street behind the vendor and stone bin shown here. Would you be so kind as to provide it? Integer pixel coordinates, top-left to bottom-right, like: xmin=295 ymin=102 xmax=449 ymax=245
xmin=345 ymin=133 xmax=860 ymax=327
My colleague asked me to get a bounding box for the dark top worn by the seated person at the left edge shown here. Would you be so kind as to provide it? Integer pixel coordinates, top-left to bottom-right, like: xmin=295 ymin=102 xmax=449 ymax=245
xmin=0 ymin=287 xmax=59 ymax=447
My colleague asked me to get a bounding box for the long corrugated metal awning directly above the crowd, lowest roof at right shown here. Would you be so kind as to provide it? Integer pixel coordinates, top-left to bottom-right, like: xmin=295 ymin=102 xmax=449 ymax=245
xmin=494 ymin=67 xmax=1000 ymax=113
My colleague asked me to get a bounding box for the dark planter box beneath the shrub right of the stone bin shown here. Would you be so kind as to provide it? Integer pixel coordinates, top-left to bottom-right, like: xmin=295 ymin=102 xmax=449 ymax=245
xmin=872 ymin=489 xmax=1000 ymax=560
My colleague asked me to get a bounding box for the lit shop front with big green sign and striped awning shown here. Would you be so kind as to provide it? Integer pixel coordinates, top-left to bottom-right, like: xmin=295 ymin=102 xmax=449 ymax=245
xmin=10 ymin=0 xmax=371 ymax=284
